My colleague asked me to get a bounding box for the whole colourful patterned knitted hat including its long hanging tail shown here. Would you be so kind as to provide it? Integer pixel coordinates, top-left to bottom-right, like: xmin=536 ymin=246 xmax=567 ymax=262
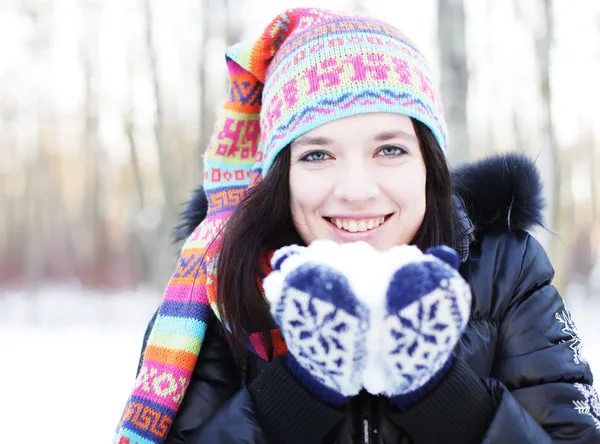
xmin=114 ymin=8 xmax=446 ymax=444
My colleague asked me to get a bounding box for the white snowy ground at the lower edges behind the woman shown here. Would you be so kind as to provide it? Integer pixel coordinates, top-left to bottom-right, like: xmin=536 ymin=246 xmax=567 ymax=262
xmin=0 ymin=288 xmax=600 ymax=444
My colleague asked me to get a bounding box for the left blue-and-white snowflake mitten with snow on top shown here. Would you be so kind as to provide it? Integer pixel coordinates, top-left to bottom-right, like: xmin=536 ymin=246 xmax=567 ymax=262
xmin=263 ymin=240 xmax=373 ymax=405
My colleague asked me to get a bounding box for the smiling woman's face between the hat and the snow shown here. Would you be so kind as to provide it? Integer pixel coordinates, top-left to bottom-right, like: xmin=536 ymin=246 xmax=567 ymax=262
xmin=290 ymin=113 xmax=426 ymax=250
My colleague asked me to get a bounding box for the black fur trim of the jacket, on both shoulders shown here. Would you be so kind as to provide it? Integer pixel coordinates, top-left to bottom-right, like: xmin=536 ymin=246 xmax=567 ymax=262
xmin=174 ymin=153 xmax=544 ymax=242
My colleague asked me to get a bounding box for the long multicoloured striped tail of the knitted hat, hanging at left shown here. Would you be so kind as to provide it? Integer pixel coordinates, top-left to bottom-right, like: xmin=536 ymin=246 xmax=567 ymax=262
xmin=113 ymin=45 xmax=286 ymax=444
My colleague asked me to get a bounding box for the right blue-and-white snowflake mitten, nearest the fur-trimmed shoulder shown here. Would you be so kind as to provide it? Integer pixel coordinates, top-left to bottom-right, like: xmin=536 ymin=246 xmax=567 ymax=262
xmin=365 ymin=246 xmax=471 ymax=407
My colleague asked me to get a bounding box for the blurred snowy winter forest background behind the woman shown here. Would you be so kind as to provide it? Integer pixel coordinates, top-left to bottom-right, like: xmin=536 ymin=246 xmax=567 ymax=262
xmin=0 ymin=0 xmax=600 ymax=443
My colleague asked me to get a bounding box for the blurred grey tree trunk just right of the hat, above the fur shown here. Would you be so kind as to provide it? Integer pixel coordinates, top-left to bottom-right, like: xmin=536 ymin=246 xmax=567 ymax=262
xmin=438 ymin=0 xmax=471 ymax=165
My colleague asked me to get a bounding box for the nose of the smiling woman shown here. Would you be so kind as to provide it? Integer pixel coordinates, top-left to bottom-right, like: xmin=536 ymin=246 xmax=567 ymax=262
xmin=333 ymin=165 xmax=379 ymax=205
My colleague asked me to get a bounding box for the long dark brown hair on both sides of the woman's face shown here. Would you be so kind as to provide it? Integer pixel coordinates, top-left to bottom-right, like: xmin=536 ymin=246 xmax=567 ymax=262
xmin=217 ymin=119 xmax=456 ymax=359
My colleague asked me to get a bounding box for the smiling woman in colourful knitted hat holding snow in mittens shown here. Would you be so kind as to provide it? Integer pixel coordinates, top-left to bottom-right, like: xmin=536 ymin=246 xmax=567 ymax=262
xmin=115 ymin=9 xmax=600 ymax=444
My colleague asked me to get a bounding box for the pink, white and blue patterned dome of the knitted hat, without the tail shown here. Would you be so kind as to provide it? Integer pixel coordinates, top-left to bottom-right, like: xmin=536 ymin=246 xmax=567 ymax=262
xmin=227 ymin=13 xmax=447 ymax=176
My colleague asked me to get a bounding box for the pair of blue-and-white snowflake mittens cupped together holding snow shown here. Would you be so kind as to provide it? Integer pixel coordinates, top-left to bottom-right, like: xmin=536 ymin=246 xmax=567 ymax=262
xmin=264 ymin=240 xmax=471 ymax=407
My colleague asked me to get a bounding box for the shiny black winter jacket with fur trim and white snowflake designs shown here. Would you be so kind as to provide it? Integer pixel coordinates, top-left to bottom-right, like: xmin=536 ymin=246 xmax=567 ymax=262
xmin=137 ymin=155 xmax=600 ymax=444
